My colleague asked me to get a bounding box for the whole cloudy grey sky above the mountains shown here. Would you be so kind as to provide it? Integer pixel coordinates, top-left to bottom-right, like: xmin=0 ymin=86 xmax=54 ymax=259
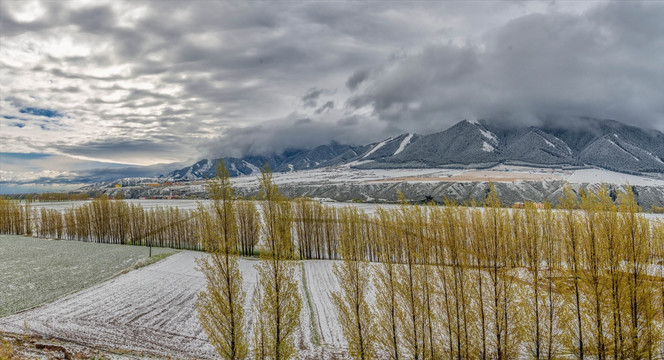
xmin=0 ymin=0 xmax=664 ymax=192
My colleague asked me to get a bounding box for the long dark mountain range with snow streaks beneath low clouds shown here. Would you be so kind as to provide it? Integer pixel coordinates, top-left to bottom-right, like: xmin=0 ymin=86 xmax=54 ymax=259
xmin=160 ymin=118 xmax=664 ymax=181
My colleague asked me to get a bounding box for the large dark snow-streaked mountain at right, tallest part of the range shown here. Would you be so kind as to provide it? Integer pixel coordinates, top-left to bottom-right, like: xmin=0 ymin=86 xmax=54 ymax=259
xmin=374 ymin=118 xmax=664 ymax=173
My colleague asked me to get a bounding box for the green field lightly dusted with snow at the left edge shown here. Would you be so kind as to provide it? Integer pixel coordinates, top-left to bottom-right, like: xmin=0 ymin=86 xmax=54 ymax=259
xmin=0 ymin=235 xmax=174 ymax=316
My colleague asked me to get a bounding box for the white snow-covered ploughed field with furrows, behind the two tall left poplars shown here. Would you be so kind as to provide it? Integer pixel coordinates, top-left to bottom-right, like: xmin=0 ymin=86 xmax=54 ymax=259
xmin=0 ymin=251 xmax=343 ymax=359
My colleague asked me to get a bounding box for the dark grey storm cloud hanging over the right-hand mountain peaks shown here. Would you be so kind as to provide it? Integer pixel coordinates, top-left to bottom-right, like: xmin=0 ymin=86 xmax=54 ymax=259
xmin=347 ymin=2 xmax=664 ymax=131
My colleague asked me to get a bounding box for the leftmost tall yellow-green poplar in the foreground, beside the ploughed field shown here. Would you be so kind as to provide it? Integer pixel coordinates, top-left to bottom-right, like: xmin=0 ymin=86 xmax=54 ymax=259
xmin=196 ymin=160 xmax=247 ymax=360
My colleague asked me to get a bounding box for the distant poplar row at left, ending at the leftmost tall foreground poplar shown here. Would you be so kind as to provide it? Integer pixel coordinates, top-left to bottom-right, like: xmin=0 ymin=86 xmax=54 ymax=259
xmin=0 ymin=196 xmax=202 ymax=250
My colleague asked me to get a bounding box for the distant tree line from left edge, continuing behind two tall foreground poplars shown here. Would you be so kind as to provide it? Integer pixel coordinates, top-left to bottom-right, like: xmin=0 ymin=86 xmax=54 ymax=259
xmin=0 ymin=190 xmax=339 ymax=259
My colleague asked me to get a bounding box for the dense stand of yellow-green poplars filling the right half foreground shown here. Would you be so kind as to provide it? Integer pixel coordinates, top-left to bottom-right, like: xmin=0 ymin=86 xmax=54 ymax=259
xmin=333 ymin=187 xmax=664 ymax=359
